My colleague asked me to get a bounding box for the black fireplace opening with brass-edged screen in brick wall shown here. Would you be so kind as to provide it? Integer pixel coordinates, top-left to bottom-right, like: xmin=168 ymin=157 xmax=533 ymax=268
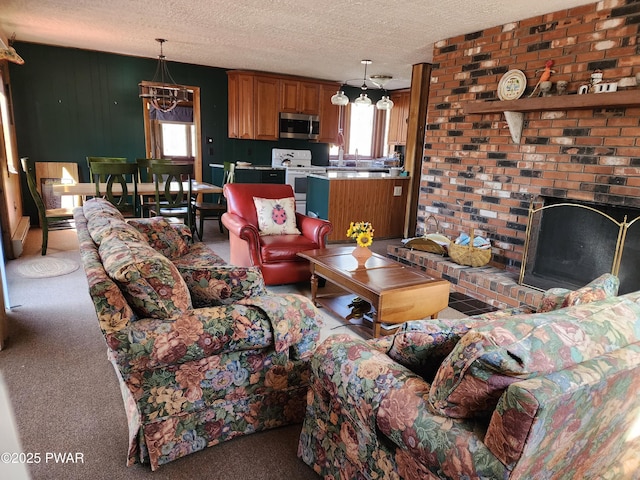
xmin=520 ymin=197 xmax=640 ymax=294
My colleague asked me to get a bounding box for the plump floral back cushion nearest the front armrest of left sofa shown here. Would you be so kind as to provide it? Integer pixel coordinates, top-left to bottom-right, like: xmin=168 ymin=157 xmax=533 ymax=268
xmin=99 ymin=234 xmax=192 ymax=318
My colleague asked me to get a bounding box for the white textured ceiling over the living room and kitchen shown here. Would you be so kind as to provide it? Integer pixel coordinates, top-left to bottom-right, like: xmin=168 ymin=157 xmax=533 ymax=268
xmin=0 ymin=0 xmax=594 ymax=90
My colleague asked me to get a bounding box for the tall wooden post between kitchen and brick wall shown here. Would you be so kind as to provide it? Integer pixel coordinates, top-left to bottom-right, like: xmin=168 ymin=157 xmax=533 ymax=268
xmin=404 ymin=63 xmax=431 ymax=238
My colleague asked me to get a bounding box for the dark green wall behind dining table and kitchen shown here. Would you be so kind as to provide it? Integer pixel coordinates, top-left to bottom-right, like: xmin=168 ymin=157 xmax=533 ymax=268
xmin=10 ymin=43 xmax=328 ymax=223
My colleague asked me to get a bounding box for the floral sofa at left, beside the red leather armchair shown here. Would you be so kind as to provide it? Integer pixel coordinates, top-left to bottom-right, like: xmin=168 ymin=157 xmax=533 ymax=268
xmin=74 ymin=199 xmax=321 ymax=470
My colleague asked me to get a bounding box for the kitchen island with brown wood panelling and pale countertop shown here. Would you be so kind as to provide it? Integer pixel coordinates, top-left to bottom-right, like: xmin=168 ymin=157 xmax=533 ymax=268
xmin=307 ymin=171 xmax=409 ymax=243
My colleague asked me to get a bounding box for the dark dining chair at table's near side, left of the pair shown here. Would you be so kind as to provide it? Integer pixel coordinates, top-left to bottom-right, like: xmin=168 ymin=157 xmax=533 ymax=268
xmin=91 ymin=162 xmax=140 ymax=217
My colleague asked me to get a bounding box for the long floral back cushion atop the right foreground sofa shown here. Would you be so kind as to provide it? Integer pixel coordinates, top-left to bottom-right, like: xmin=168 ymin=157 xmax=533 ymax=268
xmin=429 ymin=297 xmax=640 ymax=418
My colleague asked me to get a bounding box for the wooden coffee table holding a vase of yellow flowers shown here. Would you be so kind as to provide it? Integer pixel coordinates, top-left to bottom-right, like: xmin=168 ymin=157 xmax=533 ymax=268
xmin=298 ymin=246 xmax=450 ymax=337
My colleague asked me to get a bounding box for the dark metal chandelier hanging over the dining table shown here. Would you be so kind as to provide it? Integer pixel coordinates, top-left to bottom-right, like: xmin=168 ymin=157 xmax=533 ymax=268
xmin=138 ymin=38 xmax=189 ymax=112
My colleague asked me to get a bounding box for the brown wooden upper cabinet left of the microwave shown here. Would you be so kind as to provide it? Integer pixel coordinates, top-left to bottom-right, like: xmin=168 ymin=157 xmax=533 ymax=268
xmin=227 ymin=71 xmax=280 ymax=140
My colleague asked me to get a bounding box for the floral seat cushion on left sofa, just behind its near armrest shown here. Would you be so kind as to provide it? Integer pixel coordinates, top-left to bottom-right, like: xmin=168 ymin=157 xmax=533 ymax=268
xmin=177 ymin=265 xmax=266 ymax=307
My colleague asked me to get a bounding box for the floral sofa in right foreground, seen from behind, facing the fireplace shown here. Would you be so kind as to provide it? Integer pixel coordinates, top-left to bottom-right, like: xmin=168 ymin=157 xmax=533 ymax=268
xmin=298 ymin=275 xmax=640 ymax=480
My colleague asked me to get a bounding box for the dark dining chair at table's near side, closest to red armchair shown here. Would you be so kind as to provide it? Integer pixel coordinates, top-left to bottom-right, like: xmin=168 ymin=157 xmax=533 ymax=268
xmin=149 ymin=162 xmax=194 ymax=232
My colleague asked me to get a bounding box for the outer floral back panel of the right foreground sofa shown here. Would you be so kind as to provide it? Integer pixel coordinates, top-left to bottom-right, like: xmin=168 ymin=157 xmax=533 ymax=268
xmin=485 ymin=344 xmax=640 ymax=478
